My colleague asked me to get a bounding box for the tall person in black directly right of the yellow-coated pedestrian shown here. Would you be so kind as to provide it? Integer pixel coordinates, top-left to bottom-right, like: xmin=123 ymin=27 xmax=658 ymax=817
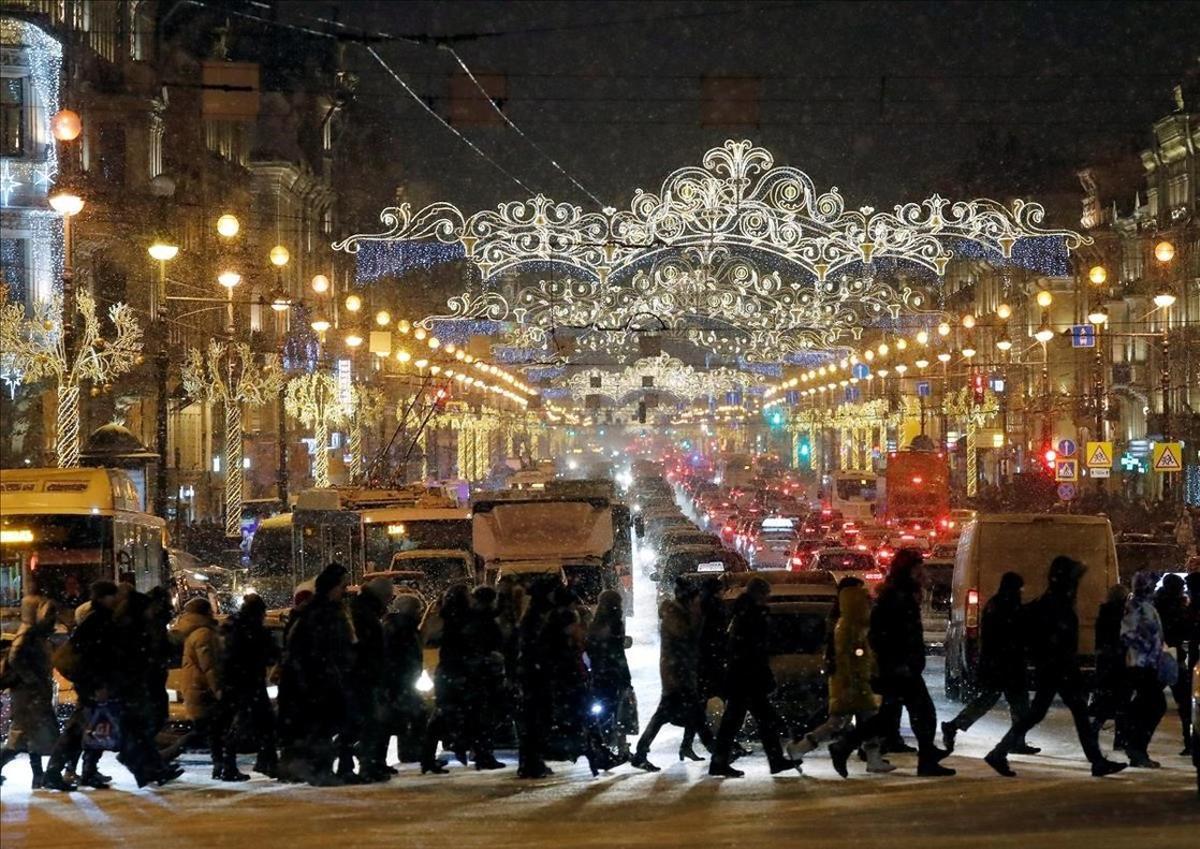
xmin=871 ymin=548 xmax=954 ymax=776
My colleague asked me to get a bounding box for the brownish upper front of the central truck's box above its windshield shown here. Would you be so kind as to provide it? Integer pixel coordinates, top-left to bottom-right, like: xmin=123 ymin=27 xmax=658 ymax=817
xmin=472 ymin=501 xmax=613 ymax=562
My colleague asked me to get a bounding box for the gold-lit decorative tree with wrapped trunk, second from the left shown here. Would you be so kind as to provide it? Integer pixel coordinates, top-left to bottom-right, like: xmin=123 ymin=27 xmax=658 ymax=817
xmin=181 ymin=341 xmax=283 ymax=537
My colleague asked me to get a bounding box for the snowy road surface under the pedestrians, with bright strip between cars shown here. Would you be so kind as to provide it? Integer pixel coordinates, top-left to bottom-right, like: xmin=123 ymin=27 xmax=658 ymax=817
xmin=0 ymin=539 xmax=1200 ymax=849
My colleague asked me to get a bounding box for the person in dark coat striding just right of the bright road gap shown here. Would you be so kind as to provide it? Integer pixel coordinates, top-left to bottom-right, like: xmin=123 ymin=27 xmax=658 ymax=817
xmin=629 ymin=580 xmax=724 ymax=772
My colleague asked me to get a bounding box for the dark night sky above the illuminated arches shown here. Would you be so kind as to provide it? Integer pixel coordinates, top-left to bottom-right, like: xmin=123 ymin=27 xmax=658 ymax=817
xmin=282 ymin=1 xmax=1200 ymax=228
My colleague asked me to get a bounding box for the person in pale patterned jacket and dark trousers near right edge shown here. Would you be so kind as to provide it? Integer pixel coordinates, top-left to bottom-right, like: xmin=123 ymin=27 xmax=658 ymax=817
xmin=1121 ymin=572 xmax=1166 ymax=769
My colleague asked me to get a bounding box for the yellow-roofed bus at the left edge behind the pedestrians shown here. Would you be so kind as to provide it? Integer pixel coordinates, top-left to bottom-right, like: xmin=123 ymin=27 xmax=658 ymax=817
xmin=0 ymin=469 xmax=168 ymax=618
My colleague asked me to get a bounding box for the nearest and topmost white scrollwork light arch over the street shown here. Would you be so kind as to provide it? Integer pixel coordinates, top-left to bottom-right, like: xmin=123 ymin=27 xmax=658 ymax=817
xmin=334 ymin=139 xmax=1090 ymax=282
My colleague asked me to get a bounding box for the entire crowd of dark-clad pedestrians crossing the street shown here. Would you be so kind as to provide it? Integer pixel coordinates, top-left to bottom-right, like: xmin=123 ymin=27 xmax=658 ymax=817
xmin=0 ymin=550 xmax=1200 ymax=790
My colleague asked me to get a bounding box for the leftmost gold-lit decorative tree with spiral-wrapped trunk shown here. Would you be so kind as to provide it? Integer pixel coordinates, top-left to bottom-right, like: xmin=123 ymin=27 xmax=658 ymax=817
xmin=0 ymin=293 xmax=142 ymax=469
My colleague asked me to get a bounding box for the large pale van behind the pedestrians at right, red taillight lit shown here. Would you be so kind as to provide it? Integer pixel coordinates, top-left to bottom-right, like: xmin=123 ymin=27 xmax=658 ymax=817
xmin=946 ymin=513 xmax=1120 ymax=699
